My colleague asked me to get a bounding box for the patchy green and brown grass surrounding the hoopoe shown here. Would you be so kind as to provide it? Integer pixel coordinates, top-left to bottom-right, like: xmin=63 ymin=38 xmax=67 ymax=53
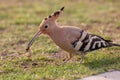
xmin=0 ymin=0 xmax=120 ymax=80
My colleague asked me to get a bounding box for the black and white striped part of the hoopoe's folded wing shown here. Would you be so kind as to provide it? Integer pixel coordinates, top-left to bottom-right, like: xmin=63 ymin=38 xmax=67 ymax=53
xmin=72 ymin=31 xmax=109 ymax=52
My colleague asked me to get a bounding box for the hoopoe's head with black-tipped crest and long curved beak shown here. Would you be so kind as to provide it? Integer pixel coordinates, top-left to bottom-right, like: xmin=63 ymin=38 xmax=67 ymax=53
xmin=26 ymin=7 xmax=64 ymax=50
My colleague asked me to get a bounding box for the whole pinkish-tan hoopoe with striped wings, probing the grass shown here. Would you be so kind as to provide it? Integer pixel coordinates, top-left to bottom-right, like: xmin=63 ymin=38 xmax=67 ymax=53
xmin=26 ymin=7 xmax=120 ymax=63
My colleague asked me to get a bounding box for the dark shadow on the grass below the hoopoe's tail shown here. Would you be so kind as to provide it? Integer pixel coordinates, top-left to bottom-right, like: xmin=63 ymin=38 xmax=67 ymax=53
xmin=83 ymin=56 xmax=120 ymax=69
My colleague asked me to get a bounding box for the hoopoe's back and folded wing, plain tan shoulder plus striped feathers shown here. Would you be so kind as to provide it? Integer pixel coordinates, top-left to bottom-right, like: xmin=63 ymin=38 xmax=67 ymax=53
xmin=63 ymin=27 xmax=114 ymax=52
